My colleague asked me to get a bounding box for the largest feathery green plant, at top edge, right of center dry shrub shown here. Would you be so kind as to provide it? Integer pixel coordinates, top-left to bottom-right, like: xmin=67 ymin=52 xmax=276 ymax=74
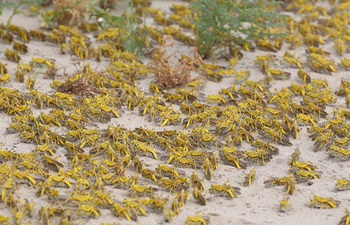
xmin=191 ymin=0 xmax=287 ymax=57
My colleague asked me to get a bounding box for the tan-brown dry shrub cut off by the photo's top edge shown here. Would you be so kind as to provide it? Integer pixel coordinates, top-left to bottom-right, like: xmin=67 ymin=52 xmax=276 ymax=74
xmin=53 ymin=0 xmax=92 ymax=26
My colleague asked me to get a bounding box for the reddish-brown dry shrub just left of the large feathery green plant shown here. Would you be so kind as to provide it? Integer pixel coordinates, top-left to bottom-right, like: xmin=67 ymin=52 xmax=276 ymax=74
xmin=151 ymin=36 xmax=202 ymax=89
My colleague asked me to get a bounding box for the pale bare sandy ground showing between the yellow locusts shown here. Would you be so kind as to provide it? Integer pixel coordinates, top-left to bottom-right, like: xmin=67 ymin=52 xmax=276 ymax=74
xmin=0 ymin=1 xmax=350 ymax=225
